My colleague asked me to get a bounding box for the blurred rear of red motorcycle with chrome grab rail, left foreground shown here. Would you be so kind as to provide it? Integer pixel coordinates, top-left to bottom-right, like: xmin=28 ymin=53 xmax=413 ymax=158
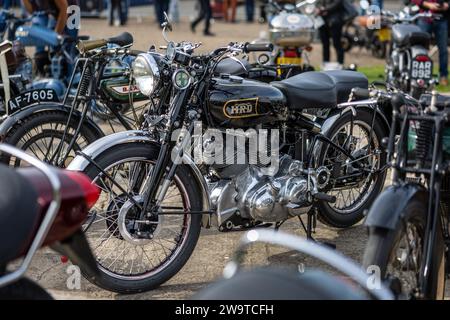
xmin=0 ymin=144 xmax=99 ymax=300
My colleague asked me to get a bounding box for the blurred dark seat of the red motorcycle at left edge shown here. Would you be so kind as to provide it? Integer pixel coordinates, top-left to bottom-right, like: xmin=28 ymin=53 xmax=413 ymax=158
xmin=0 ymin=165 xmax=40 ymax=267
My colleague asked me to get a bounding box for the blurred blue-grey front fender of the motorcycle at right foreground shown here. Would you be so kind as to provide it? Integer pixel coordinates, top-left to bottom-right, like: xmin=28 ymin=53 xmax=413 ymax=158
xmin=364 ymin=183 xmax=428 ymax=230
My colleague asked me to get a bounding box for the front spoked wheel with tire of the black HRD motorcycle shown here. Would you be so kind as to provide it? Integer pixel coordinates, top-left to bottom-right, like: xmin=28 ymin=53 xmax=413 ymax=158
xmin=80 ymin=144 xmax=201 ymax=293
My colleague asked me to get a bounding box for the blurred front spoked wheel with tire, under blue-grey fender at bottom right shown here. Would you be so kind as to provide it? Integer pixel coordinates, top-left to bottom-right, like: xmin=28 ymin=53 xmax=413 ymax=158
xmin=363 ymin=199 xmax=445 ymax=299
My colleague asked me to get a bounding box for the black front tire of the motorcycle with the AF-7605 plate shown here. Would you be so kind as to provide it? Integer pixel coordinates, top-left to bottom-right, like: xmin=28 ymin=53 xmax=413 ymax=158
xmin=0 ymin=110 xmax=101 ymax=165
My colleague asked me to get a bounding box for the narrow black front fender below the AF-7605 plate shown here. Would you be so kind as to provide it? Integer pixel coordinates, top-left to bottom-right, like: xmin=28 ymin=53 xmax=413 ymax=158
xmin=0 ymin=103 xmax=105 ymax=141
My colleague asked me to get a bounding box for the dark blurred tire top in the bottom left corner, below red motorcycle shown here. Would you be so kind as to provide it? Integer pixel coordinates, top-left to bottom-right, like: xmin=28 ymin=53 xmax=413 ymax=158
xmin=0 ymin=278 xmax=53 ymax=300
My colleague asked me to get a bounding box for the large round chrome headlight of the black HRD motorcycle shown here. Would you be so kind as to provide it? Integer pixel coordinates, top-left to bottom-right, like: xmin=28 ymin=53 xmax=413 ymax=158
xmin=133 ymin=53 xmax=159 ymax=96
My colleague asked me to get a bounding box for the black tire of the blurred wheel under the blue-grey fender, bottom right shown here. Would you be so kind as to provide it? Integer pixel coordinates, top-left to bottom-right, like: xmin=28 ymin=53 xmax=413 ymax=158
xmin=363 ymin=198 xmax=446 ymax=299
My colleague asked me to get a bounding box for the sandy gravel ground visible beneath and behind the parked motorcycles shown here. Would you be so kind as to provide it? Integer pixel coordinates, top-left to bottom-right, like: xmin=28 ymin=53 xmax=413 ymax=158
xmin=22 ymin=18 xmax=450 ymax=299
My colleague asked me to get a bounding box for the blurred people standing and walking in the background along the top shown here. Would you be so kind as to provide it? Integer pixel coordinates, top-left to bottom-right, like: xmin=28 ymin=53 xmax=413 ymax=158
xmin=3 ymin=0 xmax=450 ymax=85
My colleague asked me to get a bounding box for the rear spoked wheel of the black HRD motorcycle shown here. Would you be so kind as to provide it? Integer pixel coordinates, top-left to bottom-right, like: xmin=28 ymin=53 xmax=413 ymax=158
xmin=318 ymin=109 xmax=388 ymax=228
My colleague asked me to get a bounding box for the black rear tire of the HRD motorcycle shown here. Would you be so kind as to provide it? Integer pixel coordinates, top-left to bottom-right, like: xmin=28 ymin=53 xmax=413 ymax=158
xmin=318 ymin=108 xmax=389 ymax=228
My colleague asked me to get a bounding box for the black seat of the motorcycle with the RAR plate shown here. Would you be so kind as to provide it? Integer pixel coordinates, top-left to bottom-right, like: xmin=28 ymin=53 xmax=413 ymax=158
xmin=392 ymin=24 xmax=431 ymax=48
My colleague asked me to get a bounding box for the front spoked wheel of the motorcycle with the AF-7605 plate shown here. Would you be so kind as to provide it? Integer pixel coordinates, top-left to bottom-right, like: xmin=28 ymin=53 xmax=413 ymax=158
xmin=1 ymin=111 xmax=100 ymax=167
